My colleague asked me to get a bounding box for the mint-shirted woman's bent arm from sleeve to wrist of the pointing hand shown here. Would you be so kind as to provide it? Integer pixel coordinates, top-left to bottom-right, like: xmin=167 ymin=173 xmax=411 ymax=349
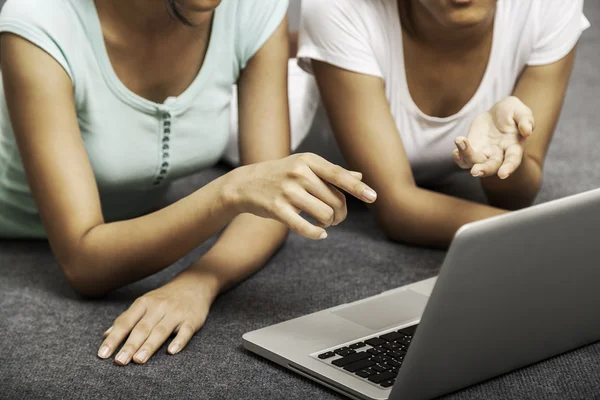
xmin=1 ymin=34 xmax=235 ymax=295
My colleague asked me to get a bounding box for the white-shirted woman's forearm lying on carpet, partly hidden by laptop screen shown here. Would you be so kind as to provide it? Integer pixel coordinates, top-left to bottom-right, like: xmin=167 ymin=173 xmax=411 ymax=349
xmin=376 ymin=187 xmax=506 ymax=249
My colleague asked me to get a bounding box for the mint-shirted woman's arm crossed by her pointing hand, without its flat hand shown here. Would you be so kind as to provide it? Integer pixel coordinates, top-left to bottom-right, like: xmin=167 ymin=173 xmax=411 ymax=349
xmin=190 ymin=19 xmax=290 ymax=290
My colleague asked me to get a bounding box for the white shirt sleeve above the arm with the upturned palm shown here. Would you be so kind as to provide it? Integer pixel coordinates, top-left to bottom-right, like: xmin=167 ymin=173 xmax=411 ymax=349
xmin=527 ymin=0 xmax=590 ymax=66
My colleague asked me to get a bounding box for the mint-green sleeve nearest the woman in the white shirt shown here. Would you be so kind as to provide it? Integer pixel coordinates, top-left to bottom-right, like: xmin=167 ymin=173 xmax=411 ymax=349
xmin=237 ymin=0 xmax=289 ymax=69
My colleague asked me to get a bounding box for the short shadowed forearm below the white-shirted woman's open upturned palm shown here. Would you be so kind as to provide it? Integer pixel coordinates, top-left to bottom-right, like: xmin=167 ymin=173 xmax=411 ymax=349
xmin=481 ymin=154 xmax=542 ymax=210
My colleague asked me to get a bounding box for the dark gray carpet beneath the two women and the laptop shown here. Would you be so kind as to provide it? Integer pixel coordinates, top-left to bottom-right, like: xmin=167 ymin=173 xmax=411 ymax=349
xmin=0 ymin=0 xmax=600 ymax=400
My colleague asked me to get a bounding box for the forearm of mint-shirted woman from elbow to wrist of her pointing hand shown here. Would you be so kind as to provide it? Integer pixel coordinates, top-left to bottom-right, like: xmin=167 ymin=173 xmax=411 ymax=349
xmin=68 ymin=178 xmax=235 ymax=295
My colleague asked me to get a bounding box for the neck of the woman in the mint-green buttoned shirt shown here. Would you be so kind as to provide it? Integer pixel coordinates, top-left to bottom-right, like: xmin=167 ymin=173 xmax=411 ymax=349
xmin=94 ymin=0 xmax=213 ymax=37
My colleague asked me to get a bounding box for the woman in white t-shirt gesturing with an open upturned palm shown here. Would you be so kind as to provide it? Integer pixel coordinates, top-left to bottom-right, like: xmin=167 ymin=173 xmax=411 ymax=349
xmin=298 ymin=0 xmax=589 ymax=247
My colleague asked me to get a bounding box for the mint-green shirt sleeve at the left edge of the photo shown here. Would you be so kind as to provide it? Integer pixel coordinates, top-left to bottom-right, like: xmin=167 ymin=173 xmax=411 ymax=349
xmin=0 ymin=0 xmax=73 ymax=80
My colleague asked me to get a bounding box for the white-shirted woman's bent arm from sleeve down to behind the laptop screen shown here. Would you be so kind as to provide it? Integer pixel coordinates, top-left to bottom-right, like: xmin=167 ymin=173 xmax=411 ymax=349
xmin=313 ymin=61 xmax=504 ymax=247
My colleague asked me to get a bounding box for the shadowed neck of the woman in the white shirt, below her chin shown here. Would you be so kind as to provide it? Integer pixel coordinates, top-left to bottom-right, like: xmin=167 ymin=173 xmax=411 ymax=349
xmin=405 ymin=0 xmax=495 ymax=51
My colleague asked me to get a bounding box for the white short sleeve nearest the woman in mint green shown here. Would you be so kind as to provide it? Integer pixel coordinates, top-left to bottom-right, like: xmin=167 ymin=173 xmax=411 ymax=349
xmin=298 ymin=0 xmax=383 ymax=78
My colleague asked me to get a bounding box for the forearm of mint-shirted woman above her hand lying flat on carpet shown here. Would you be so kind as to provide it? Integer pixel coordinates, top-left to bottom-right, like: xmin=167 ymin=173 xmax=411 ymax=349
xmin=189 ymin=214 xmax=288 ymax=291
